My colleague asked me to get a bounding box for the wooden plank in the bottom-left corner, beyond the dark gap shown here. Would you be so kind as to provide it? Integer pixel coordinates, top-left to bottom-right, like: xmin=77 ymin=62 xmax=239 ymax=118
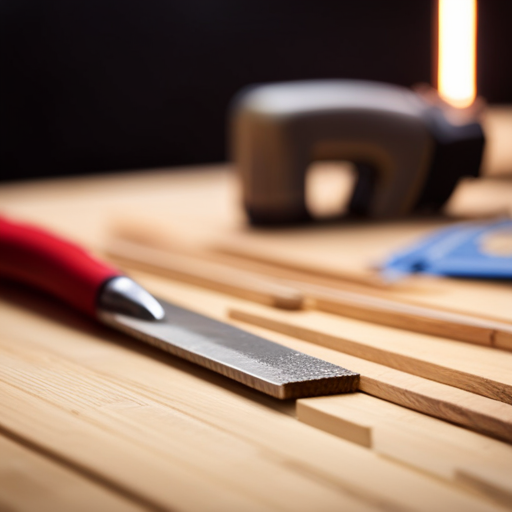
xmin=0 ymin=435 xmax=151 ymax=512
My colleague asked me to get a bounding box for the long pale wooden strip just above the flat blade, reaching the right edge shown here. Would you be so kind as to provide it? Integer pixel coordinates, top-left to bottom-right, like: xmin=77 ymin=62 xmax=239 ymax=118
xmin=226 ymin=306 xmax=512 ymax=404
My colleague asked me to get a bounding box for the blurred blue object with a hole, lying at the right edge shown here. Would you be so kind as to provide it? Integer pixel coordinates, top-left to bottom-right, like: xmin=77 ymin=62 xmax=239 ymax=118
xmin=382 ymin=219 xmax=512 ymax=281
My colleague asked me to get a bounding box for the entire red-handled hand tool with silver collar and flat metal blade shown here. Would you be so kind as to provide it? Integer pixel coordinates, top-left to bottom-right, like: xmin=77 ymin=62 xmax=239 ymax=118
xmin=0 ymin=217 xmax=359 ymax=399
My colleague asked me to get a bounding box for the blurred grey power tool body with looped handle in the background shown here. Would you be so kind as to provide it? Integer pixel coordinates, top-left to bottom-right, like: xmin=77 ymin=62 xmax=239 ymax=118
xmin=231 ymin=80 xmax=484 ymax=223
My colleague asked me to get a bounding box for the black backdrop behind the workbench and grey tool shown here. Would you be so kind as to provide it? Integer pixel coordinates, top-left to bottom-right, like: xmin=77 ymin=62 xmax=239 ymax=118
xmin=0 ymin=0 xmax=512 ymax=179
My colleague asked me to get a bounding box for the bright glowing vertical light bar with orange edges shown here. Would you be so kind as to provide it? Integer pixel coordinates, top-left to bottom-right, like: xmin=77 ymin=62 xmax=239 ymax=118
xmin=438 ymin=0 xmax=477 ymax=108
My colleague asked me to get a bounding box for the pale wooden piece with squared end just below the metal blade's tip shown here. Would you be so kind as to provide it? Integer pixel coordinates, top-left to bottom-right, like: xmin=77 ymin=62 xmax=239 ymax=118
xmin=297 ymin=393 xmax=512 ymax=505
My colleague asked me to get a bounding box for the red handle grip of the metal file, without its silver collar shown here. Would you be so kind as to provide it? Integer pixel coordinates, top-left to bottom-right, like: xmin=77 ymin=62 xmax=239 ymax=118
xmin=0 ymin=216 xmax=121 ymax=317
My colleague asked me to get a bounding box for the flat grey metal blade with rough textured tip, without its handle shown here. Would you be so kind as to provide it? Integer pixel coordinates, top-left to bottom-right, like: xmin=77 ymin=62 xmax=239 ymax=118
xmin=99 ymin=299 xmax=359 ymax=399
